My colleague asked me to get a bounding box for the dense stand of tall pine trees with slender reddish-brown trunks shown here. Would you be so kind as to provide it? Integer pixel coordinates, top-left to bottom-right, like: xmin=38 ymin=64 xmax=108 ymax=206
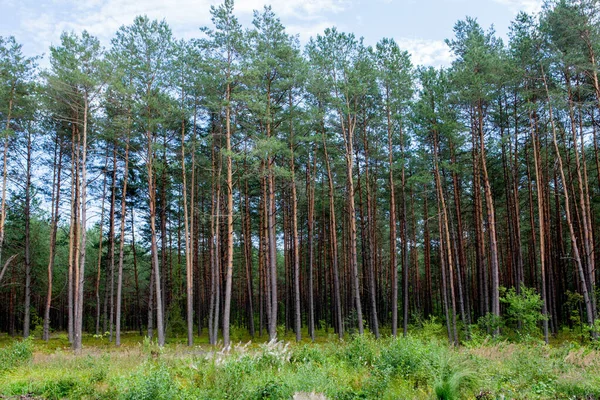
xmin=0 ymin=0 xmax=600 ymax=350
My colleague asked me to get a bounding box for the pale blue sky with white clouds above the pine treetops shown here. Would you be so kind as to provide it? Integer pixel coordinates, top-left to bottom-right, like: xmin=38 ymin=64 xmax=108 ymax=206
xmin=0 ymin=0 xmax=542 ymax=66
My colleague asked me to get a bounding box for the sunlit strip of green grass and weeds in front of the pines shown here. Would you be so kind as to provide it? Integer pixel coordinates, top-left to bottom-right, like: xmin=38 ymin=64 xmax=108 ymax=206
xmin=0 ymin=327 xmax=600 ymax=399
